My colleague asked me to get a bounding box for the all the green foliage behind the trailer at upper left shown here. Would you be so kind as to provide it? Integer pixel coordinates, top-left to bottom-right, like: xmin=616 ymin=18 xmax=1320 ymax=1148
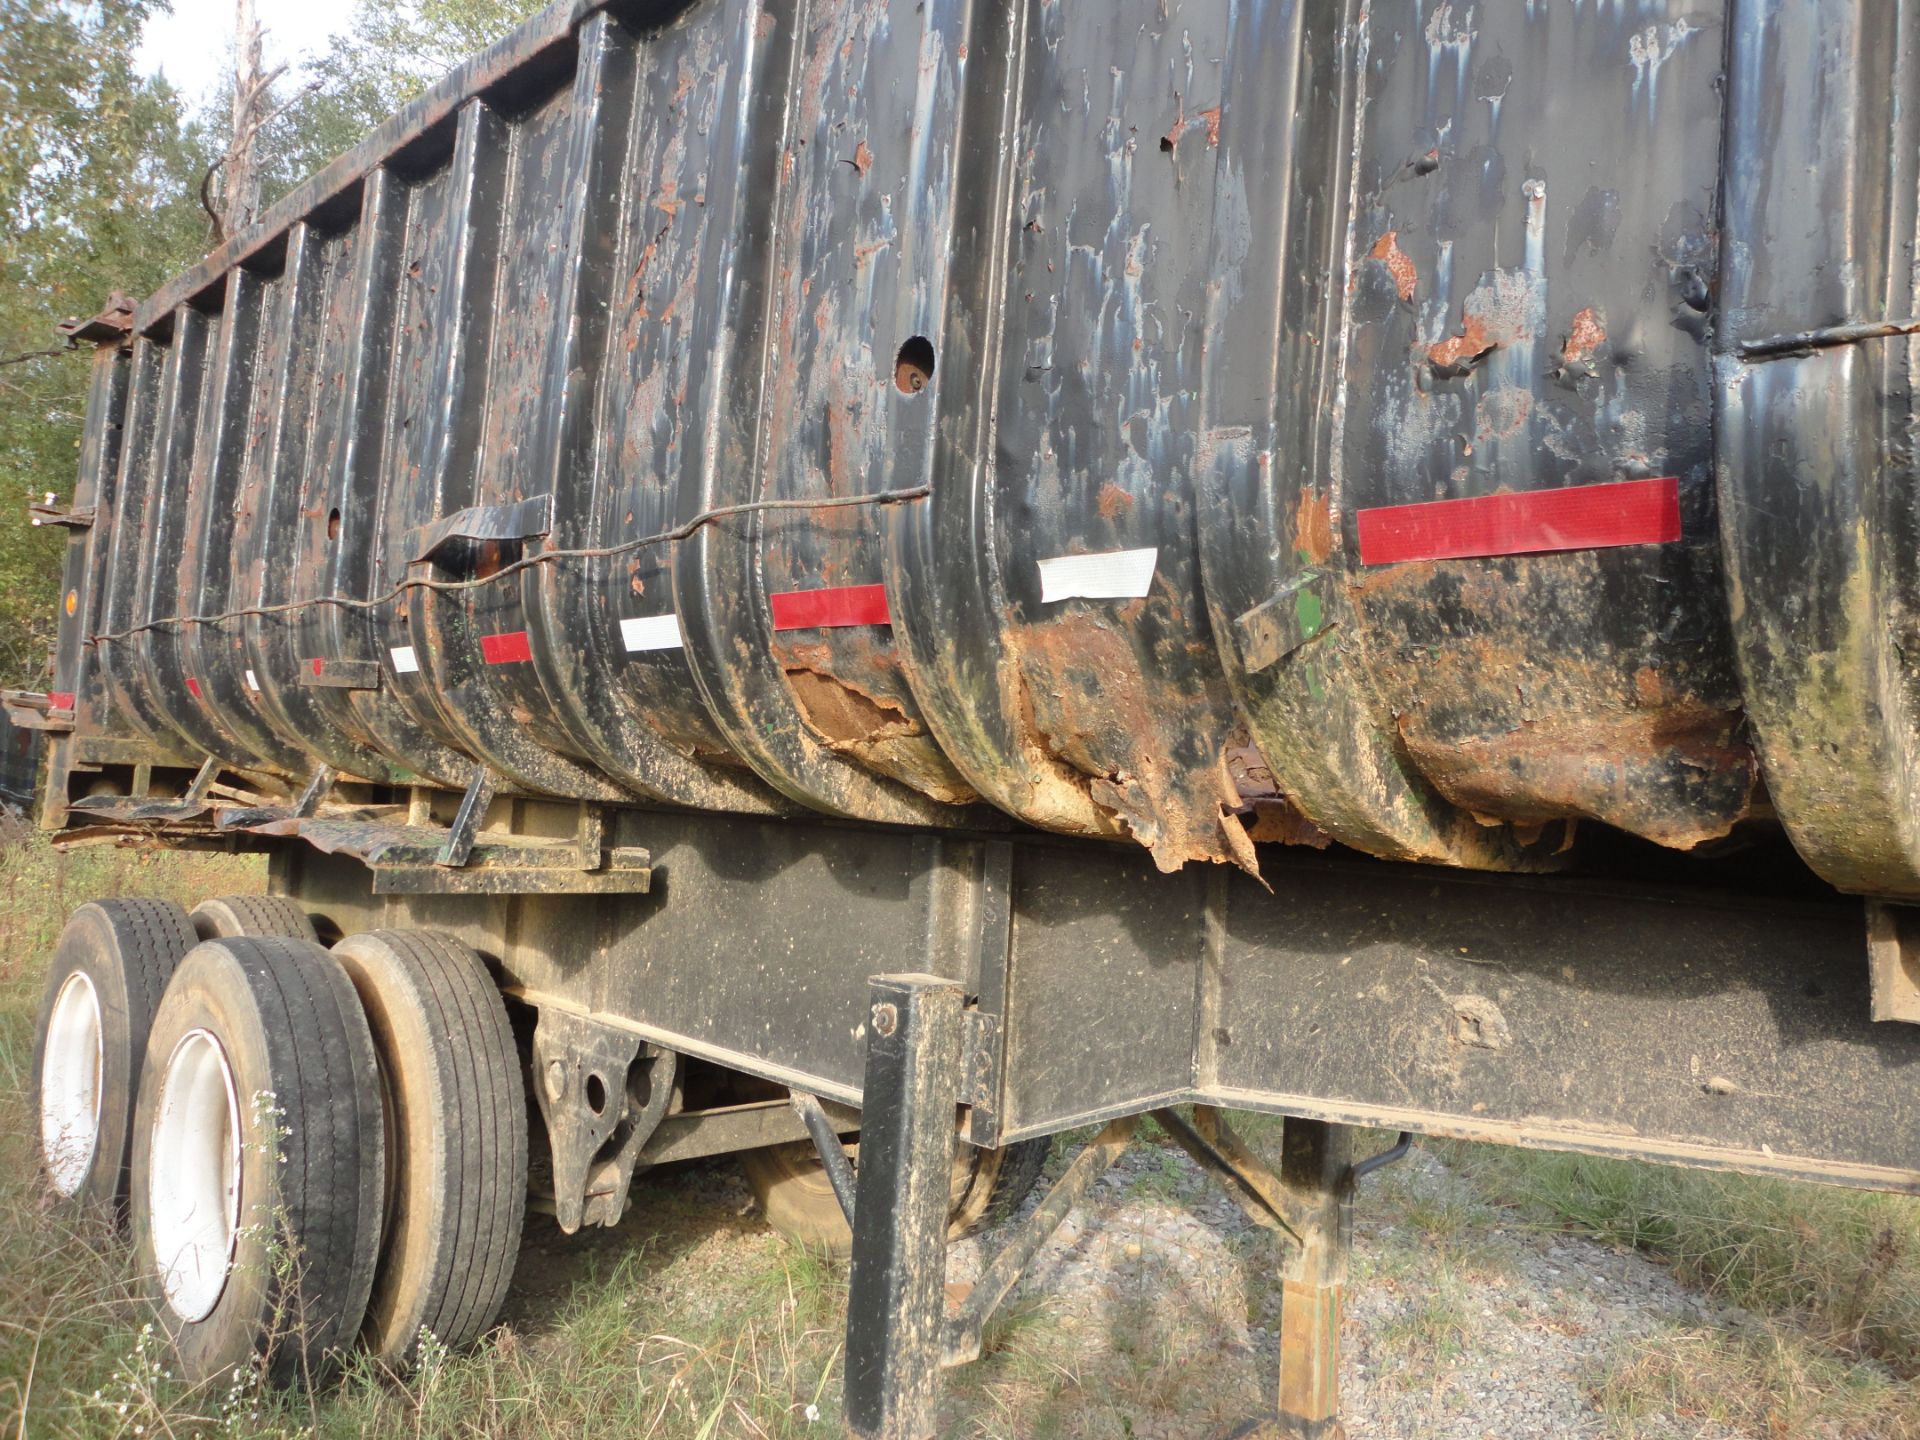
xmin=0 ymin=0 xmax=540 ymax=687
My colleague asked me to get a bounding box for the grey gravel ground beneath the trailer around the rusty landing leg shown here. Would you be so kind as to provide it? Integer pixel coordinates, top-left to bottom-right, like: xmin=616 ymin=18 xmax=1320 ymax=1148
xmin=948 ymin=1146 xmax=1741 ymax=1440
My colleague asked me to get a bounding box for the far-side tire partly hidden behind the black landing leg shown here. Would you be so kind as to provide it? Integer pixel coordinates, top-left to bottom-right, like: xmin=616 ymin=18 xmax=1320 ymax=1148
xmin=739 ymin=1140 xmax=1050 ymax=1260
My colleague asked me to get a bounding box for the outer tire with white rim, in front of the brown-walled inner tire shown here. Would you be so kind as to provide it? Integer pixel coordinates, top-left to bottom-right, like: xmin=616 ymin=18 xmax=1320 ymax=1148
xmin=132 ymin=937 xmax=386 ymax=1384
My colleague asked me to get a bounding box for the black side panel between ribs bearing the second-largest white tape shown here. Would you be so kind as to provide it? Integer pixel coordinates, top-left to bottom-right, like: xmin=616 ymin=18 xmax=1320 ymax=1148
xmin=518 ymin=0 xmax=780 ymax=810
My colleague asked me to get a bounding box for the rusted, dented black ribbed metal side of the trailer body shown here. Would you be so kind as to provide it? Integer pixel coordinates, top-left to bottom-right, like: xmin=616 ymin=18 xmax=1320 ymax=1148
xmin=45 ymin=0 xmax=1920 ymax=897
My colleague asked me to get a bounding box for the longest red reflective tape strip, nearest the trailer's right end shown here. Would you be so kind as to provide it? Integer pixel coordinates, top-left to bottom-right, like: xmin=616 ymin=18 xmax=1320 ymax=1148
xmin=1356 ymin=474 xmax=1680 ymax=564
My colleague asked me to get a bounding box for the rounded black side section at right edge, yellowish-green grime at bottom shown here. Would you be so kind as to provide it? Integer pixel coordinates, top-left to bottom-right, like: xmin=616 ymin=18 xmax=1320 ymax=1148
xmin=1715 ymin=0 xmax=1920 ymax=895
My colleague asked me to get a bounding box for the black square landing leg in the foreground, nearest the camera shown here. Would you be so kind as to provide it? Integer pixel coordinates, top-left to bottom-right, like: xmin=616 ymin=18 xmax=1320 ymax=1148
xmin=847 ymin=975 xmax=966 ymax=1440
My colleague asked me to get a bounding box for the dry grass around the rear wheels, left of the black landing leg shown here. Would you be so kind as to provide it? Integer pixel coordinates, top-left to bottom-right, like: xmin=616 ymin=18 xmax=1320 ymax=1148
xmin=0 ymin=839 xmax=845 ymax=1440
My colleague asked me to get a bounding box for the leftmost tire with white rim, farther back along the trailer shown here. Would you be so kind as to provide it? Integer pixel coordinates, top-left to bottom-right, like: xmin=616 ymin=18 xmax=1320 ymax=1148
xmin=33 ymin=900 xmax=194 ymax=1206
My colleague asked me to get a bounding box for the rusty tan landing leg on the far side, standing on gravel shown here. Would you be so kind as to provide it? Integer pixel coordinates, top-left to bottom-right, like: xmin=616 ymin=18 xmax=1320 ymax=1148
xmin=1279 ymin=1119 xmax=1354 ymax=1440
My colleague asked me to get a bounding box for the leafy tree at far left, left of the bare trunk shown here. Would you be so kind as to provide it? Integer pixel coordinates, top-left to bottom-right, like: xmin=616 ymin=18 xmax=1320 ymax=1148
xmin=0 ymin=0 xmax=205 ymax=685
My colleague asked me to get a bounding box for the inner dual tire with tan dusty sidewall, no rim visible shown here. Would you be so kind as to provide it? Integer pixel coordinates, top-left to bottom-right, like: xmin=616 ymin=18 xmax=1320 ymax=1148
xmin=332 ymin=929 xmax=526 ymax=1365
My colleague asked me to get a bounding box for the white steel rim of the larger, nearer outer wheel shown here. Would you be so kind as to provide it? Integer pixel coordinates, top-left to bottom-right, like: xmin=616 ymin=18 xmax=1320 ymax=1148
xmin=148 ymin=1029 xmax=240 ymax=1323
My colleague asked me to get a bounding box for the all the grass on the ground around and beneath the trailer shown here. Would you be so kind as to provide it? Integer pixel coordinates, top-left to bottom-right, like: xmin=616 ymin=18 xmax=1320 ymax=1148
xmin=0 ymin=841 xmax=1920 ymax=1440
